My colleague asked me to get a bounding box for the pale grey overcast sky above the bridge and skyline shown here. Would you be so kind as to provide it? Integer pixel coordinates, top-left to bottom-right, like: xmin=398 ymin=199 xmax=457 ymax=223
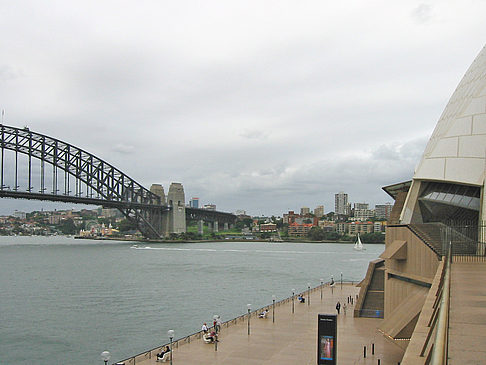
xmin=0 ymin=0 xmax=486 ymax=215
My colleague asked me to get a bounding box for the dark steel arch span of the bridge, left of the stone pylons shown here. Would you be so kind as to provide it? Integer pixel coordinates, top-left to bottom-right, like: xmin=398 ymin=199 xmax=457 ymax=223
xmin=0 ymin=125 xmax=170 ymax=238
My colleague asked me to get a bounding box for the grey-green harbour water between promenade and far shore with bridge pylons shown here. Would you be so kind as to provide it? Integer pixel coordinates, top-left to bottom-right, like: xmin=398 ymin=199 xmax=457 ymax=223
xmin=0 ymin=237 xmax=384 ymax=365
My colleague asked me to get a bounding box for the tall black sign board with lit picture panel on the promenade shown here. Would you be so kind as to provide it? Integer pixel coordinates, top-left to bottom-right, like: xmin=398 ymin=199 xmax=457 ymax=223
xmin=317 ymin=314 xmax=337 ymax=365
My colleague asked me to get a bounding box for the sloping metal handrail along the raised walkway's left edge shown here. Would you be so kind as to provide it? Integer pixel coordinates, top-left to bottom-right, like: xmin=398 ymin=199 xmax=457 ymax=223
xmin=430 ymin=242 xmax=452 ymax=365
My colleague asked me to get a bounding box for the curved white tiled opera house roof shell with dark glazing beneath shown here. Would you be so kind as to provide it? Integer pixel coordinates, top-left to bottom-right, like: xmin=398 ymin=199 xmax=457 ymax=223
xmin=400 ymin=43 xmax=486 ymax=225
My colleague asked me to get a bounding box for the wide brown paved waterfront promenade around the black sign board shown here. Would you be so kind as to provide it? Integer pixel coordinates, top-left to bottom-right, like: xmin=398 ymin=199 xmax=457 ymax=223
xmin=126 ymin=284 xmax=403 ymax=365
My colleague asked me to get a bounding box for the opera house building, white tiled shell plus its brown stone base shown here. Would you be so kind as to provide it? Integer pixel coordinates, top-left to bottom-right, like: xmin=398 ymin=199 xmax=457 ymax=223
xmin=354 ymin=43 xmax=486 ymax=365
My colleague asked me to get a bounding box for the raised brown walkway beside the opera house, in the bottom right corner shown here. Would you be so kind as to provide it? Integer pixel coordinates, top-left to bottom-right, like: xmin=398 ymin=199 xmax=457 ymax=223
xmin=449 ymin=263 xmax=486 ymax=365
